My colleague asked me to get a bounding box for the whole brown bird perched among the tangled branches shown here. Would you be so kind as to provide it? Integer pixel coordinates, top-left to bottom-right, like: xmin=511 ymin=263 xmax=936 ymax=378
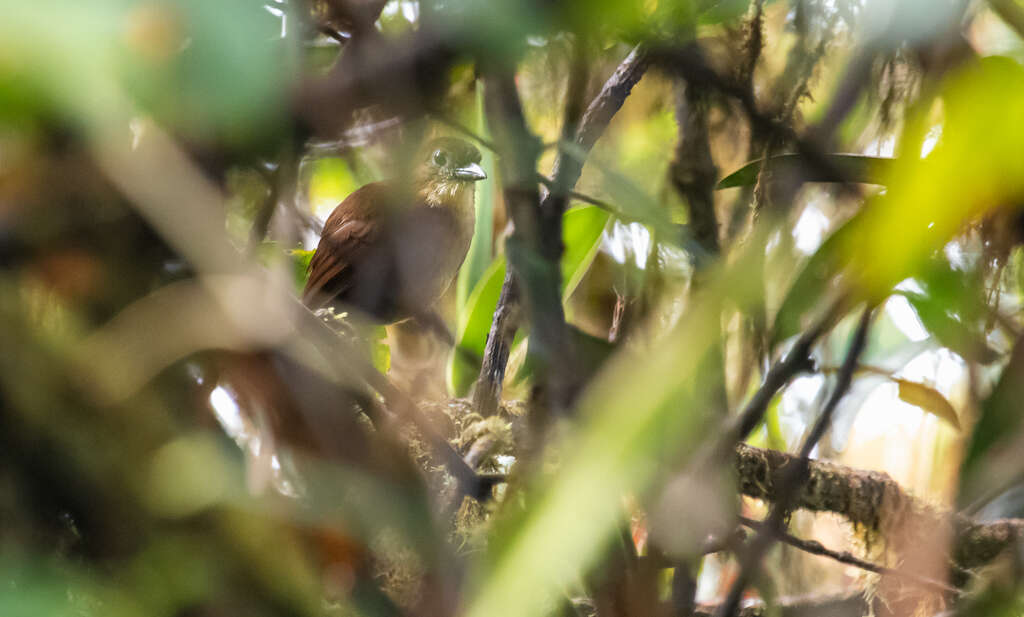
xmin=302 ymin=137 xmax=486 ymax=323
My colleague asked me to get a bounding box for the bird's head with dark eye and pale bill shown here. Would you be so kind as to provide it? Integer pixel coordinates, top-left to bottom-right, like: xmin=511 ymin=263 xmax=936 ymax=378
xmin=418 ymin=137 xmax=487 ymax=206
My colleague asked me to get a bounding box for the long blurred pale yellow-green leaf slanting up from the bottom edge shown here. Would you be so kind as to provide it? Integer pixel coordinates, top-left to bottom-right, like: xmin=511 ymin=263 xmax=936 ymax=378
xmin=466 ymin=272 xmax=749 ymax=617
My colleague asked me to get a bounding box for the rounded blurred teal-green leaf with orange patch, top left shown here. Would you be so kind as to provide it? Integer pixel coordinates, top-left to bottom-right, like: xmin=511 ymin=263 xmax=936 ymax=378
xmin=119 ymin=0 xmax=287 ymax=142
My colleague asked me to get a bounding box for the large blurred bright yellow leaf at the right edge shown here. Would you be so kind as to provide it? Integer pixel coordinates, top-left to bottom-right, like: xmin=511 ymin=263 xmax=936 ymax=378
xmin=846 ymin=56 xmax=1024 ymax=297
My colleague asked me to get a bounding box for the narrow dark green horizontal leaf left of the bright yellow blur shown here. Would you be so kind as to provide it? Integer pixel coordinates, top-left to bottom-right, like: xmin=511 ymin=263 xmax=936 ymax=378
xmin=717 ymin=155 xmax=894 ymax=189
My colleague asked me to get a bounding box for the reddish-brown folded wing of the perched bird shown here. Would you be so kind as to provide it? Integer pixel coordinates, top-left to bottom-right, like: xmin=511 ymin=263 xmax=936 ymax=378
xmin=302 ymin=182 xmax=390 ymax=308
